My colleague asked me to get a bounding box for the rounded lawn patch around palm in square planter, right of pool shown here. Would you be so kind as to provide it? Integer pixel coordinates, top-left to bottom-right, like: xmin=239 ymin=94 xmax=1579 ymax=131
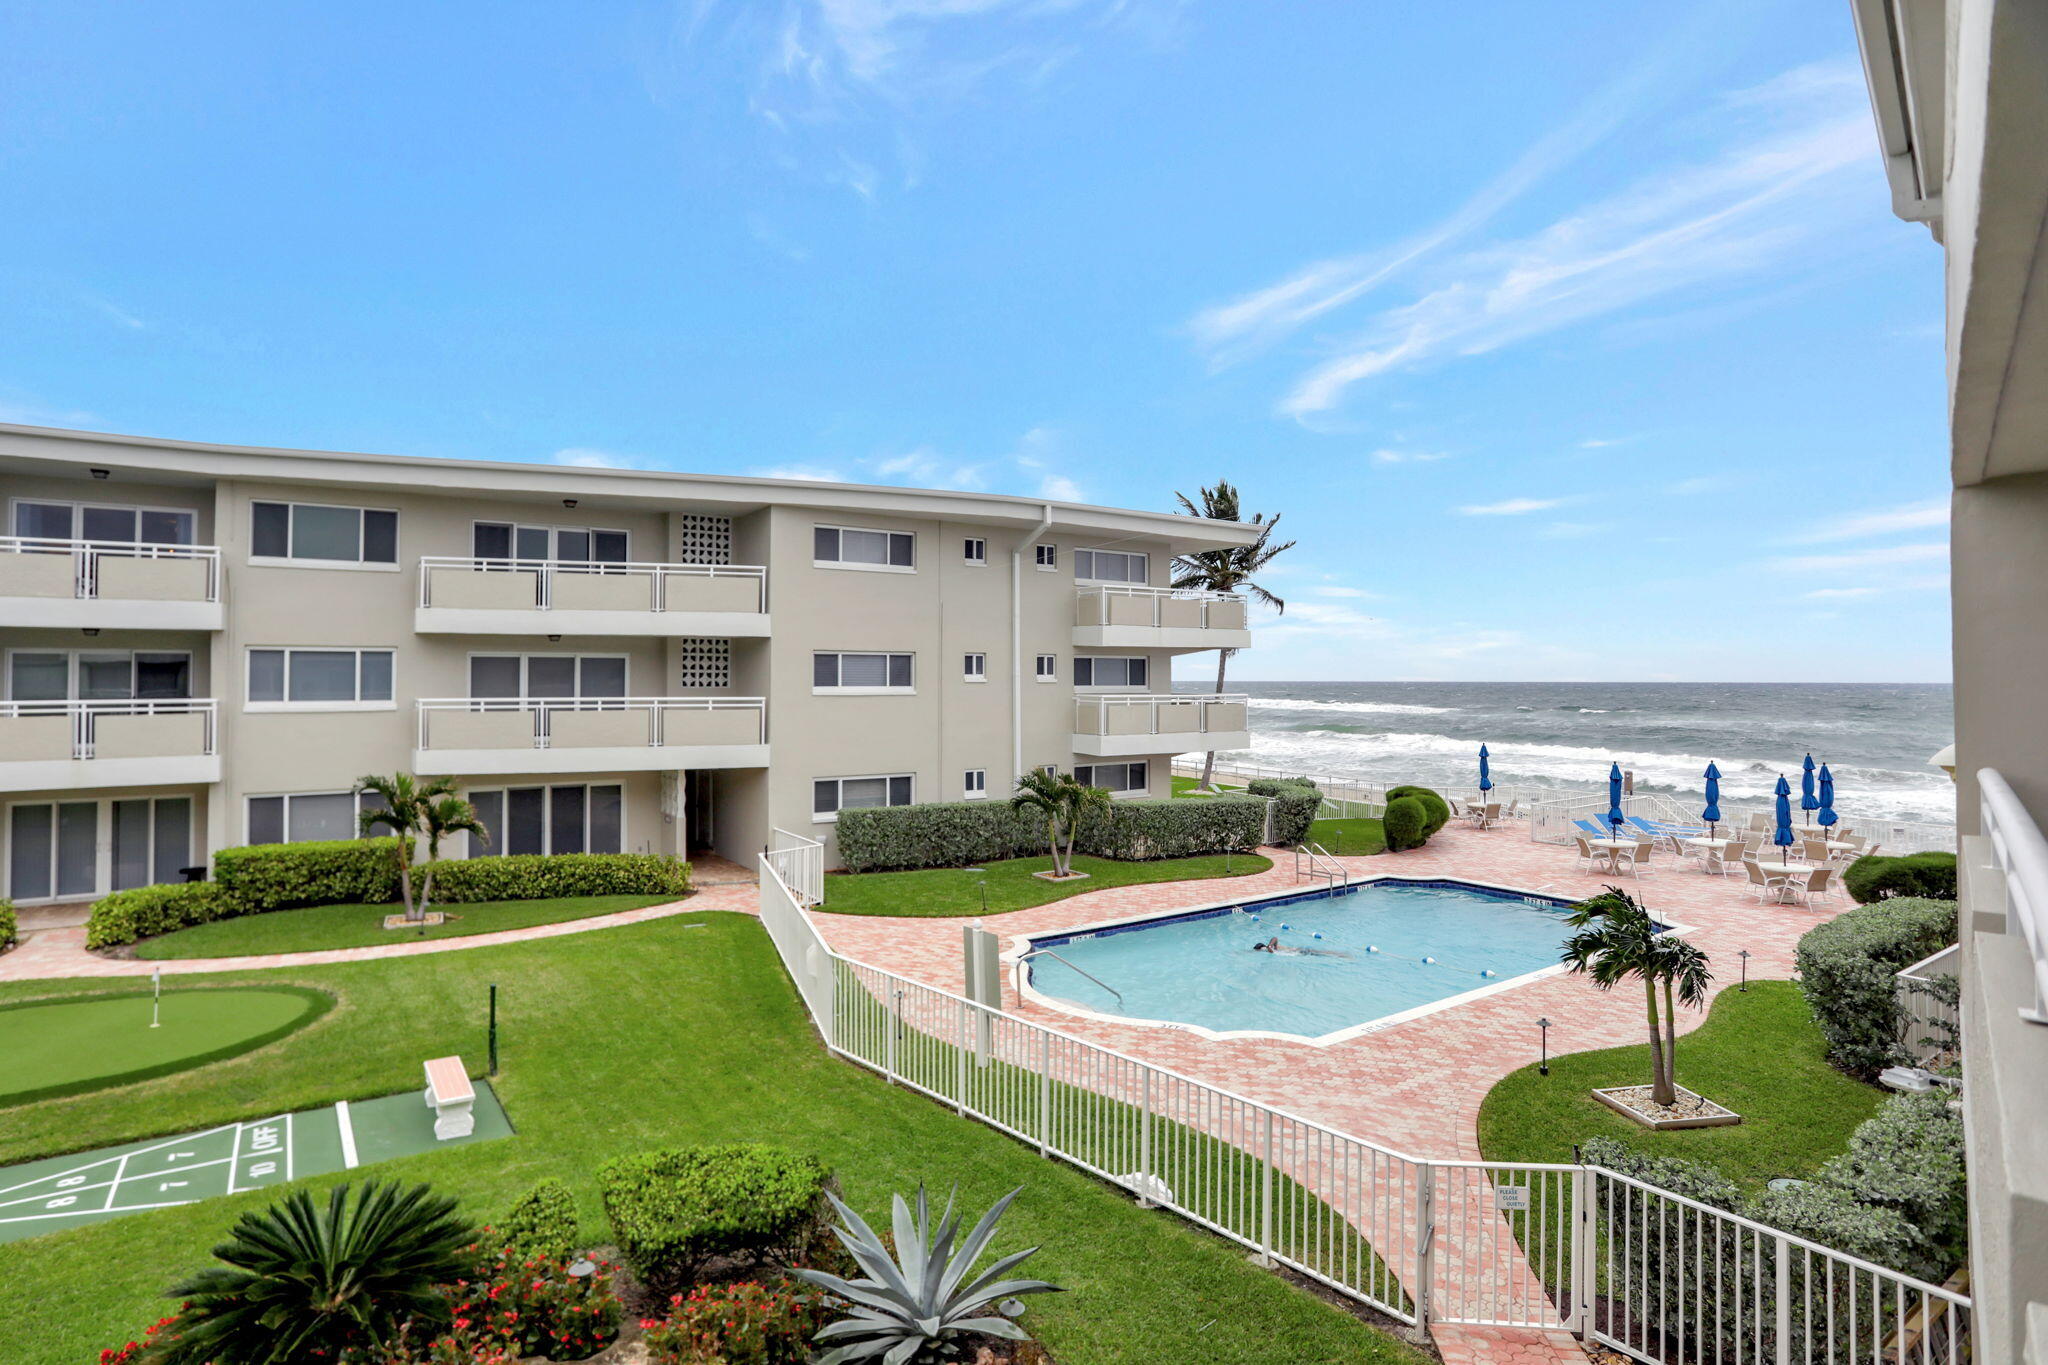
xmin=1479 ymin=980 xmax=1884 ymax=1193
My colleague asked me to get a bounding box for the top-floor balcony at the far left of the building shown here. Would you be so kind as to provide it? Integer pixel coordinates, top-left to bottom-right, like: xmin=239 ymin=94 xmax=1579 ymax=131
xmin=0 ymin=536 xmax=221 ymax=630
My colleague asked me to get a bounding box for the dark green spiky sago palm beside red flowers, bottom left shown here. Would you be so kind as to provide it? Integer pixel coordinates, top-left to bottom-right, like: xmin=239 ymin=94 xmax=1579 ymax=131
xmin=152 ymin=1181 xmax=475 ymax=1365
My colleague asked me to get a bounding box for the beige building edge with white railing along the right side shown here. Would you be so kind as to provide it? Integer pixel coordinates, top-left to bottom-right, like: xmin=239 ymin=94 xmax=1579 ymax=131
xmin=1851 ymin=0 xmax=2048 ymax=1365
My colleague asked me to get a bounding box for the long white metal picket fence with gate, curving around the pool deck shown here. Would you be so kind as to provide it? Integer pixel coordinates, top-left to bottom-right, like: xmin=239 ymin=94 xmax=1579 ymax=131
xmin=760 ymin=833 xmax=1970 ymax=1365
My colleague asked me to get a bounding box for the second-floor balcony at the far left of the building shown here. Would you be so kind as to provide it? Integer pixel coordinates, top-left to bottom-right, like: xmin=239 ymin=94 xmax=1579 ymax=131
xmin=0 ymin=698 xmax=221 ymax=792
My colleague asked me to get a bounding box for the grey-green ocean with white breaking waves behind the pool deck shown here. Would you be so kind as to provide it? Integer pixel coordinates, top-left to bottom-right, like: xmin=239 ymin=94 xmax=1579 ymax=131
xmin=1180 ymin=681 xmax=1956 ymax=825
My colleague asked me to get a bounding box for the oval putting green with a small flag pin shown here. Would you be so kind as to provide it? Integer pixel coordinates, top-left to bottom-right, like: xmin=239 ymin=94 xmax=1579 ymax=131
xmin=0 ymin=986 xmax=334 ymax=1105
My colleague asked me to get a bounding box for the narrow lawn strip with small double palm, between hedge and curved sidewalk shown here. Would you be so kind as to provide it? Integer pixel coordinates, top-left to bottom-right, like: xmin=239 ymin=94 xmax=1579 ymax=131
xmin=135 ymin=896 xmax=674 ymax=958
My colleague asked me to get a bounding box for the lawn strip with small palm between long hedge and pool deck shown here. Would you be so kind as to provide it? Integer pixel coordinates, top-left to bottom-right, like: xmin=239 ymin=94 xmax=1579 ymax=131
xmin=823 ymin=853 xmax=1272 ymax=917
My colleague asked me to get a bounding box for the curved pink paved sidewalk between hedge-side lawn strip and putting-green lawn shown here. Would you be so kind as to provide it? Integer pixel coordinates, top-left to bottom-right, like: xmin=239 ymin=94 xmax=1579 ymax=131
xmin=0 ymin=882 xmax=760 ymax=980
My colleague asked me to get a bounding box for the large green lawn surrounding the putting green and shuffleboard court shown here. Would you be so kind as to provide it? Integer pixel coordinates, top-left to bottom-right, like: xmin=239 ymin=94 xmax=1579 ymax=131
xmin=0 ymin=913 xmax=1421 ymax=1365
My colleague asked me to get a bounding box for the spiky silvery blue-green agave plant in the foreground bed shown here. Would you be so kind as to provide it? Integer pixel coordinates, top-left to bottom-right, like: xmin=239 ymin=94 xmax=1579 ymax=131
xmin=793 ymin=1185 xmax=1059 ymax=1365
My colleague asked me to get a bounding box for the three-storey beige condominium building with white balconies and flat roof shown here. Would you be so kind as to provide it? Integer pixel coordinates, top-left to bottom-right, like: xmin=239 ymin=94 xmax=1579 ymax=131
xmin=0 ymin=426 xmax=1253 ymax=902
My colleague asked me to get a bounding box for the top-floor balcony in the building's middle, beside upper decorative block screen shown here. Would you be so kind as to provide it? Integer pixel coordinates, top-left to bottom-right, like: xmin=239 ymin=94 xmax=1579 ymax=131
xmin=412 ymin=555 xmax=768 ymax=639
